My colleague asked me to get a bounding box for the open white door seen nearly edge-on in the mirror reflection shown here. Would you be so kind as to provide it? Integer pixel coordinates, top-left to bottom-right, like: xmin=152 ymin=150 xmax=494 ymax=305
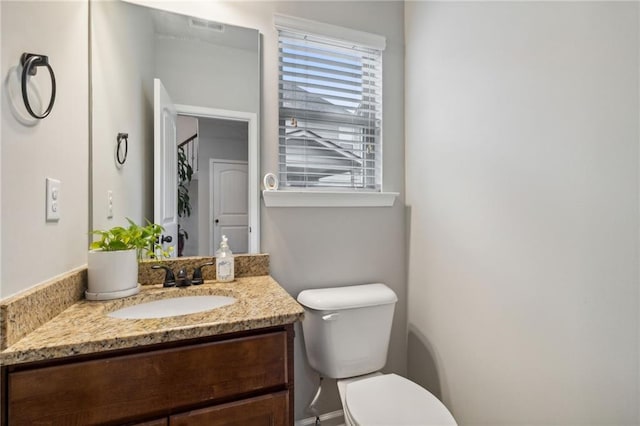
xmin=153 ymin=78 xmax=178 ymax=257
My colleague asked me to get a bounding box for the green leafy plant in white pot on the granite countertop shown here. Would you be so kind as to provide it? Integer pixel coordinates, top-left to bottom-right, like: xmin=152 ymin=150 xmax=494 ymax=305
xmin=85 ymin=218 xmax=169 ymax=300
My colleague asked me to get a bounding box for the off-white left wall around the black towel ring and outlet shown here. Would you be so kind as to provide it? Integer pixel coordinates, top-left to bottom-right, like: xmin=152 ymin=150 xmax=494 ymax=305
xmin=0 ymin=1 xmax=89 ymax=298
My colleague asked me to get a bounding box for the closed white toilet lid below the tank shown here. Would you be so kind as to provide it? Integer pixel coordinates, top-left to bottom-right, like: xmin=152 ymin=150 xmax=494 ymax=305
xmin=345 ymin=374 xmax=456 ymax=426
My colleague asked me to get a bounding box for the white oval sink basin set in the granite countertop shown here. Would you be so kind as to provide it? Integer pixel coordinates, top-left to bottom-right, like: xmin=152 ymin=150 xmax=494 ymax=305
xmin=107 ymin=296 xmax=236 ymax=319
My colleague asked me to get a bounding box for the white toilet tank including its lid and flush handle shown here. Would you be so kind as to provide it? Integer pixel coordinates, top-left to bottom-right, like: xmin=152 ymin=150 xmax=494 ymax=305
xmin=298 ymin=284 xmax=398 ymax=379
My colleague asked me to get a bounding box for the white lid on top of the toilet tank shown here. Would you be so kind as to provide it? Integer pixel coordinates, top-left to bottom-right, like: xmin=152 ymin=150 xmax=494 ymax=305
xmin=298 ymin=283 xmax=398 ymax=311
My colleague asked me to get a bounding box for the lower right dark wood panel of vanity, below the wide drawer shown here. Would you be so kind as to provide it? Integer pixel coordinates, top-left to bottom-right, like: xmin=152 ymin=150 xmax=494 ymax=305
xmin=169 ymin=391 xmax=290 ymax=426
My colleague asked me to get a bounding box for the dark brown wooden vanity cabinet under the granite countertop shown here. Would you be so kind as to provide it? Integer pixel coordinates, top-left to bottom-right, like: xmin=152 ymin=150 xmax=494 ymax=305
xmin=0 ymin=324 xmax=293 ymax=426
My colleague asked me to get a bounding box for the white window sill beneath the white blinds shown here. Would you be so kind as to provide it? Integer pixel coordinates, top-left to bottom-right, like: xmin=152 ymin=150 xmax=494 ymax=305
xmin=262 ymin=190 xmax=400 ymax=207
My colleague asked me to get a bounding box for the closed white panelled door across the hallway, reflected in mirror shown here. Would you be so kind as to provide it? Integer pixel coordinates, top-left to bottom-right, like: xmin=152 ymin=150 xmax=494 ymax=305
xmin=210 ymin=161 xmax=249 ymax=254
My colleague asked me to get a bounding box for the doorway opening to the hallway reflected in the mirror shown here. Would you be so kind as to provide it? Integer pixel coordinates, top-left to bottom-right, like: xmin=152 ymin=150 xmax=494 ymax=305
xmin=176 ymin=112 xmax=250 ymax=256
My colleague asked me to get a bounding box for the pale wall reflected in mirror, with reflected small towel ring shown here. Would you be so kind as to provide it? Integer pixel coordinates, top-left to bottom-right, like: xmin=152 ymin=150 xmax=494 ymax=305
xmin=91 ymin=1 xmax=155 ymax=233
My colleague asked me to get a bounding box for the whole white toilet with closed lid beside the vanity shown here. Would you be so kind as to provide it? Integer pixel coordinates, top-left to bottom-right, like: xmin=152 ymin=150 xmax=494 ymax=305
xmin=298 ymin=284 xmax=456 ymax=426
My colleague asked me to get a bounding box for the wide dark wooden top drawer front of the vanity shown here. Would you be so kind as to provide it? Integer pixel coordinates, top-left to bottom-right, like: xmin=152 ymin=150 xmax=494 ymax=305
xmin=8 ymin=331 xmax=288 ymax=425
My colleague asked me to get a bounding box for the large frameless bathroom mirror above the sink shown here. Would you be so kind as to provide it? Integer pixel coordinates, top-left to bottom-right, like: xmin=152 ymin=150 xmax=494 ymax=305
xmin=90 ymin=1 xmax=260 ymax=256
